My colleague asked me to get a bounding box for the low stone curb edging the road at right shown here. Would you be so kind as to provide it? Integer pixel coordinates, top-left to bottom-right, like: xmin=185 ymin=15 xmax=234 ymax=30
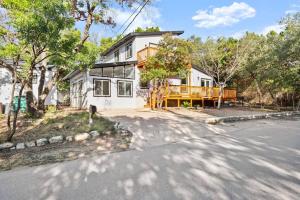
xmin=205 ymin=111 xmax=300 ymax=124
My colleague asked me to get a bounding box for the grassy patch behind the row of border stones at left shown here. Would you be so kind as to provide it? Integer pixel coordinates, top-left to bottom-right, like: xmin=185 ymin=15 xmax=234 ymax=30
xmin=0 ymin=111 xmax=114 ymax=142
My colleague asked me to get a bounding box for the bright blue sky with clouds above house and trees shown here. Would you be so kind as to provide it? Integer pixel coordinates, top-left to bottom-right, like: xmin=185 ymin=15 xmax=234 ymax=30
xmin=78 ymin=0 xmax=300 ymax=38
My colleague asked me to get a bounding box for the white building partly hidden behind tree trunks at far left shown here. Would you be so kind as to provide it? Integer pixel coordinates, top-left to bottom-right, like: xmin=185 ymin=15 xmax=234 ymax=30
xmin=0 ymin=66 xmax=57 ymax=112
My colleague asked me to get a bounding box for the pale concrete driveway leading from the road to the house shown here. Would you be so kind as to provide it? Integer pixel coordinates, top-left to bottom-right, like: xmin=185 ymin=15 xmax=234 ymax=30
xmin=100 ymin=109 xmax=213 ymax=148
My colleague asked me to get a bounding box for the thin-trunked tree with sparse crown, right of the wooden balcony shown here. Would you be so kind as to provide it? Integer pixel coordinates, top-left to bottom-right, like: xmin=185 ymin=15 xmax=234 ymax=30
xmin=193 ymin=37 xmax=247 ymax=109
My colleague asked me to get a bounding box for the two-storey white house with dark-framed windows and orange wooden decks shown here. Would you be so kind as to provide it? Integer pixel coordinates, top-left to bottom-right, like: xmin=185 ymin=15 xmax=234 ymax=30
xmin=65 ymin=31 xmax=213 ymax=110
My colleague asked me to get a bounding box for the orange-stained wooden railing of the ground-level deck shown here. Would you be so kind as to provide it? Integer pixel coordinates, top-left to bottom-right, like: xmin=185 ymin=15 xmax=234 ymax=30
xmin=165 ymin=85 xmax=237 ymax=100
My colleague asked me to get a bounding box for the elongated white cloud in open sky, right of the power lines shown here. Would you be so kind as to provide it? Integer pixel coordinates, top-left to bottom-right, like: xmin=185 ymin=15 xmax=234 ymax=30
xmin=192 ymin=2 xmax=256 ymax=28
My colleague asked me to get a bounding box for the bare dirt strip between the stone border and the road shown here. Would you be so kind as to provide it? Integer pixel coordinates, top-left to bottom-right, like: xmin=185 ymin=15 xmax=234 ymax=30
xmin=0 ymin=134 xmax=132 ymax=171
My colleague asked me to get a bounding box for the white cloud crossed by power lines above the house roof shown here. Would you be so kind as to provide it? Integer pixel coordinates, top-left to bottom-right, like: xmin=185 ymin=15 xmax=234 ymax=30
xmin=107 ymin=5 xmax=161 ymax=33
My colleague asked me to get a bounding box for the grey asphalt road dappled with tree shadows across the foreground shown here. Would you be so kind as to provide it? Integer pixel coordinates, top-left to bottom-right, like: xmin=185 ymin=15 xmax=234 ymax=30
xmin=0 ymin=120 xmax=300 ymax=200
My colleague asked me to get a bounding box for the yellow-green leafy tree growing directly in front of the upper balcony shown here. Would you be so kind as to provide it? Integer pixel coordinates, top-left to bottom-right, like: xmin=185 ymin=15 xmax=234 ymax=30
xmin=141 ymin=34 xmax=191 ymax=108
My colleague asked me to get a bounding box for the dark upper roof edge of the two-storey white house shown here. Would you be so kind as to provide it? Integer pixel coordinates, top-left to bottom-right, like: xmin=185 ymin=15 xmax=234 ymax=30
xmin=101 ymin=31 xmax=184 ymax=56
